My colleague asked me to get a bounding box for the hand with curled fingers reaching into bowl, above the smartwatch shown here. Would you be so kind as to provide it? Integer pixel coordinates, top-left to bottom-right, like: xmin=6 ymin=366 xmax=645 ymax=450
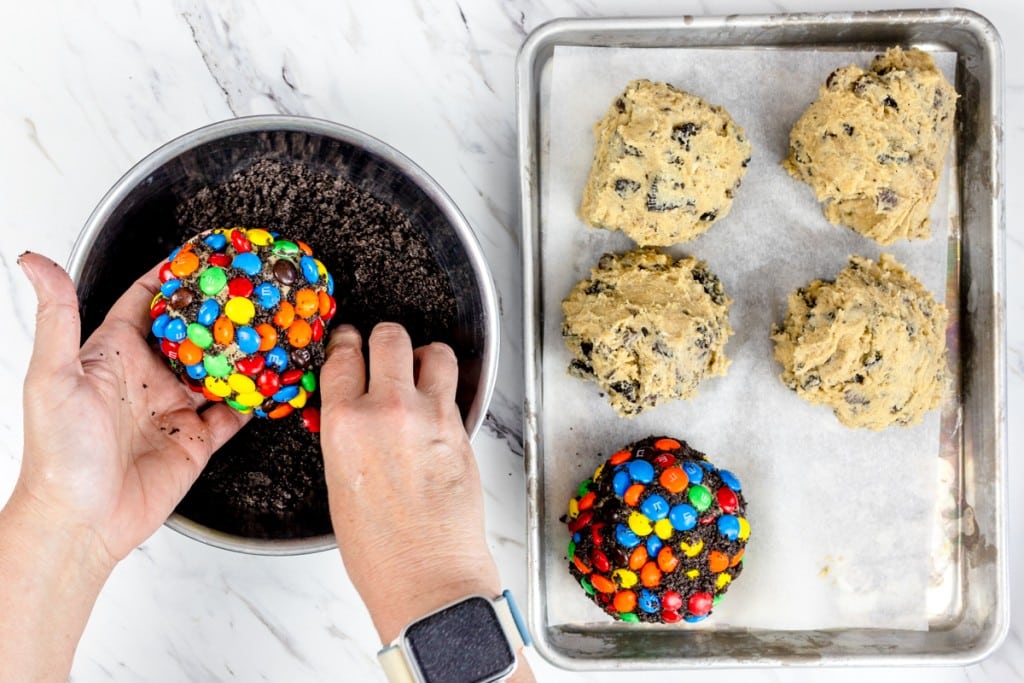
xmin=321 ymin=323 xmax=501 ymax=643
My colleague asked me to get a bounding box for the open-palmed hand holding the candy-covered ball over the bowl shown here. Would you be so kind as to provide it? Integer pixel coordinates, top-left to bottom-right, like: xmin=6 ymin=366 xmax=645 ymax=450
xmin=11 ymin=253 xmax=247 ymax=568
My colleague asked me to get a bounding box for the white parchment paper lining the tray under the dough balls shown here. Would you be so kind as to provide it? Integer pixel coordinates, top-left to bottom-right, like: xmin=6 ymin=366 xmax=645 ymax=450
xmin=540 ymin=47 xmax=958 ymax=630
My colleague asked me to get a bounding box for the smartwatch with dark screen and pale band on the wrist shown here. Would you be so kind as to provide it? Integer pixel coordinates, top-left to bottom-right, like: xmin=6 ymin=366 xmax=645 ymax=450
xmin=377 ymin=591 xmax=530 ymax=683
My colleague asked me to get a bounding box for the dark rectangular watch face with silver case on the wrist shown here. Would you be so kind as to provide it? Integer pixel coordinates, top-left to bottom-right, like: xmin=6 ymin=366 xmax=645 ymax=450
xmin=406 ymin=597 xmax=515 ymax=683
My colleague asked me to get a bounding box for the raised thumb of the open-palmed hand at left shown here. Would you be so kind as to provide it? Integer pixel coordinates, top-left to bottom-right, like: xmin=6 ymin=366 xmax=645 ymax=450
xmin=17 ymin=252 xmax=82 ymax=374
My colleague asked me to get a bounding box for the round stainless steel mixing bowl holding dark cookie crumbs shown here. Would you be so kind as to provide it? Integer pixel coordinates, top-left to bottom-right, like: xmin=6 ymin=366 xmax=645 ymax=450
xmin=69 ymin=116 xmax=499 ymax=555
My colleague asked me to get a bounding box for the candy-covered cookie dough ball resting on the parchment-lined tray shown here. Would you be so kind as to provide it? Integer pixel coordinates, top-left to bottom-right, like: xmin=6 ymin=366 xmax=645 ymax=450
xmin=565 ymin=436 xmax=751 ymax=624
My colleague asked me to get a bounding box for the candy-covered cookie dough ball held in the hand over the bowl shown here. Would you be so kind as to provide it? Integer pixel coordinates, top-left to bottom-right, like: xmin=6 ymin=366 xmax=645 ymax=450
xmin=150 ymin=227 xmax=336 ymax=431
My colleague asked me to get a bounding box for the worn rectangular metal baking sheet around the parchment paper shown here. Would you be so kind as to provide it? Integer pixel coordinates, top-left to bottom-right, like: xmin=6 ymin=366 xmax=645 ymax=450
xmin=517 ymin=10 xmax=1009 ymax=669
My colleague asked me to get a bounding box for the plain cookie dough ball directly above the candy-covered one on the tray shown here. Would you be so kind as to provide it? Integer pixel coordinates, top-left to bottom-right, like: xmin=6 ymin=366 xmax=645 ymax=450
xmin=562 ymin=247 xmax=732 ymax=418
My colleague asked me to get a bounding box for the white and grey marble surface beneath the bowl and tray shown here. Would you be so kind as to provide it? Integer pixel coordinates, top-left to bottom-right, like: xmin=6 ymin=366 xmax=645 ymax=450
xmin=0 ymin=0 xmax=1024 ymax=683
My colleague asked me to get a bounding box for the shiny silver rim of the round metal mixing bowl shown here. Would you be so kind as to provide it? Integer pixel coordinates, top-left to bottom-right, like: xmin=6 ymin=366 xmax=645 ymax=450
xmin=68 ymin=114 xmax=500 ymax=555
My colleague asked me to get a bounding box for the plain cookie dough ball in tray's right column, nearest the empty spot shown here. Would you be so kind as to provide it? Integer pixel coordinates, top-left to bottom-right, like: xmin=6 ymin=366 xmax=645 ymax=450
xmin=772 ymin=254 xmax=949 ymax=430
